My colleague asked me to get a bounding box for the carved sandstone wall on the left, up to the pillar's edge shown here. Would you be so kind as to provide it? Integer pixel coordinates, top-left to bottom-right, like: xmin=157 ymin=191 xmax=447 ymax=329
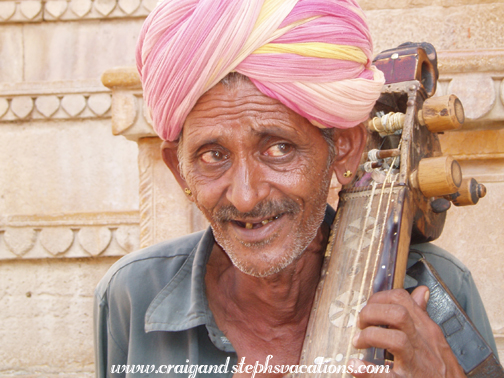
xmin=0 ymin=0 xmax=142 ymax=377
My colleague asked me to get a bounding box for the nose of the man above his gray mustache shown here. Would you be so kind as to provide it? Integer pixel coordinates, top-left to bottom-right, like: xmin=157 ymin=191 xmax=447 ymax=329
xmin=227 ymin=159 xmax=270 ymax=213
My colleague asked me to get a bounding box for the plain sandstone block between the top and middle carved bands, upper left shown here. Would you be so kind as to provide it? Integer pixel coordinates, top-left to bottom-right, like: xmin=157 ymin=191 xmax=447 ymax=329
xmin=23 ymin=19 xmax=143 ymax=82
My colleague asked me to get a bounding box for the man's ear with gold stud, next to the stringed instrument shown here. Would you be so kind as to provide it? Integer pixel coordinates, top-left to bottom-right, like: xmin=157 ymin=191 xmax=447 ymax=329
xmin=333 ymin=123 xmax=367 ymax=185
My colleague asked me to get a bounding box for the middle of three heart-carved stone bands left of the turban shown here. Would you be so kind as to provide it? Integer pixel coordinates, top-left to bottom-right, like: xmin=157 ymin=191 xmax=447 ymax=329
xmin=0 ymin=89 xmax=112 ymax=123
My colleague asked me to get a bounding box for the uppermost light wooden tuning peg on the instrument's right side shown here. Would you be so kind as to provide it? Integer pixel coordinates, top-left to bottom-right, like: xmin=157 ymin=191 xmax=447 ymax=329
xmin=418 ymin=95 xmax=465 ymax=133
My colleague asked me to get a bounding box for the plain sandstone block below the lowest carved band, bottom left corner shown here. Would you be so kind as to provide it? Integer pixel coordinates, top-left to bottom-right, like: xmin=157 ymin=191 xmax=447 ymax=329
xmin=0 ymin=257 xmax=117 ymax=378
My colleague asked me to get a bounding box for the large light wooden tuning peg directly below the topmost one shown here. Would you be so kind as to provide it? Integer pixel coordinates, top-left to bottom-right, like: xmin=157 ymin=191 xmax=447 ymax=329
xmin=411 ymin=155 xmax=462 ymax=197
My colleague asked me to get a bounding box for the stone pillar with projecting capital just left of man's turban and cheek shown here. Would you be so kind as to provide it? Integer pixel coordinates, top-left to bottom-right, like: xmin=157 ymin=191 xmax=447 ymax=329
xmin=102 ymin=67 xmax=208 ymax=247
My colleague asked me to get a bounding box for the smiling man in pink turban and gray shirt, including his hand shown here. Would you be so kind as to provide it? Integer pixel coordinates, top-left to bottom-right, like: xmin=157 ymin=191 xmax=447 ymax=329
xmin=95 ymin=0 xmax=491 ymax=378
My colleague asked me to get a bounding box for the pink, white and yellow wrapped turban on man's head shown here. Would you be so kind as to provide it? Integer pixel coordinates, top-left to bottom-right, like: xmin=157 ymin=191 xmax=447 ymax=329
xmin=136 ymin=0 xmax=384 ymax=140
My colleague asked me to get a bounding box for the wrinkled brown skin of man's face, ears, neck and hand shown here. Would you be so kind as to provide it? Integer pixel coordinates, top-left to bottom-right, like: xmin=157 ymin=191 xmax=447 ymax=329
xmin=162 ymin=80 xmax=464 ymax=378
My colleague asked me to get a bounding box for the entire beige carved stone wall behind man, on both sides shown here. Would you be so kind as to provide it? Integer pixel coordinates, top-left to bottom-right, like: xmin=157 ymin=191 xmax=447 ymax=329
xmin=0 ymin=0 xmax=504 ymax=377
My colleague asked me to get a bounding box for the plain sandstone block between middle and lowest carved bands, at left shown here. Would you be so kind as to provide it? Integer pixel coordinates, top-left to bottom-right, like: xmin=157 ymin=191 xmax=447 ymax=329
xmin=0 ymin=119 xmax=139 ymax=215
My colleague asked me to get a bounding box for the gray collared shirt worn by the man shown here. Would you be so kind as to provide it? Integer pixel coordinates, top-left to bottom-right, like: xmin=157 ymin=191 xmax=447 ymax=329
xmin=94 ymin=208 xmax=496 ymax=377
